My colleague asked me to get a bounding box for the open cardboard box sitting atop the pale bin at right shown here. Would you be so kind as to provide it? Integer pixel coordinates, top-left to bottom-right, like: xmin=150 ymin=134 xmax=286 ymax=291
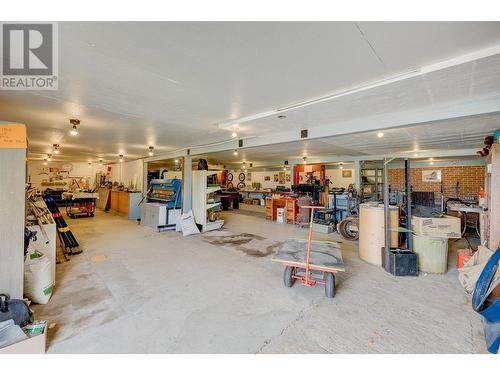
xmin=411 ymin=215 xmax=462 ymax=238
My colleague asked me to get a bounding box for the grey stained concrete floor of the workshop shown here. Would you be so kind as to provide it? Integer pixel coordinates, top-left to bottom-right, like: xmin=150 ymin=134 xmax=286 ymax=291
xmin=35 ymin=212 xmax=486 ymax=353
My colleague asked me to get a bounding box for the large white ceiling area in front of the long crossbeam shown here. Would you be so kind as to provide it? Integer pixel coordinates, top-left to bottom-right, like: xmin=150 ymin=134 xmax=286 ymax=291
xmin=0 ymin=22 xmax=500 ymax=161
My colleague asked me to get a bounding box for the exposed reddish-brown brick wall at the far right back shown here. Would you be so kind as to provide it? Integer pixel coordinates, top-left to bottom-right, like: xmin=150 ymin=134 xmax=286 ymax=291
xmin=389 ymin=165 xmax=484 ymax=200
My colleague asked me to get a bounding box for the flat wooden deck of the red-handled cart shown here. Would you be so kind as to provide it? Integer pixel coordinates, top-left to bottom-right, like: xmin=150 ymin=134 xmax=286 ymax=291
xmin=271 ymin=240 xmax=346 ymax=272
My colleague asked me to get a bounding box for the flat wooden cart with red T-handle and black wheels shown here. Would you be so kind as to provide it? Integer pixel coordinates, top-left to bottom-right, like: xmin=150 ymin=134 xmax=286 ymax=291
xmin=272 ymin=206 xmax=345 ymax=298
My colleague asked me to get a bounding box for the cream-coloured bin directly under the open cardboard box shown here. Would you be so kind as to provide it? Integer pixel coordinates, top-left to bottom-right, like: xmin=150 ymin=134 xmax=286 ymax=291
xmin=412 ymin=234 xmax=448 ymax=274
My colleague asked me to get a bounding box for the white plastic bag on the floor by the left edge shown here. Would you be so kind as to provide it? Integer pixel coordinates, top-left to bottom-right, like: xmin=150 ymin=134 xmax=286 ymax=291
xmin=24 ymin=250 xmax=54 ymax=305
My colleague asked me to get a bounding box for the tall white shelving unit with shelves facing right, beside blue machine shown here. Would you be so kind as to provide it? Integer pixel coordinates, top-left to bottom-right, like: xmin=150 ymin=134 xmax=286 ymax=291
xmin=193 ymin=171 xmax=224 ymax=232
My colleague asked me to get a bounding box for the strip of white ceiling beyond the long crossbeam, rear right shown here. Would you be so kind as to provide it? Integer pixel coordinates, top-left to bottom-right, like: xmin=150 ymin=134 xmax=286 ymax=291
xmin=202 ymin=113 xmax=500 ymax=165
